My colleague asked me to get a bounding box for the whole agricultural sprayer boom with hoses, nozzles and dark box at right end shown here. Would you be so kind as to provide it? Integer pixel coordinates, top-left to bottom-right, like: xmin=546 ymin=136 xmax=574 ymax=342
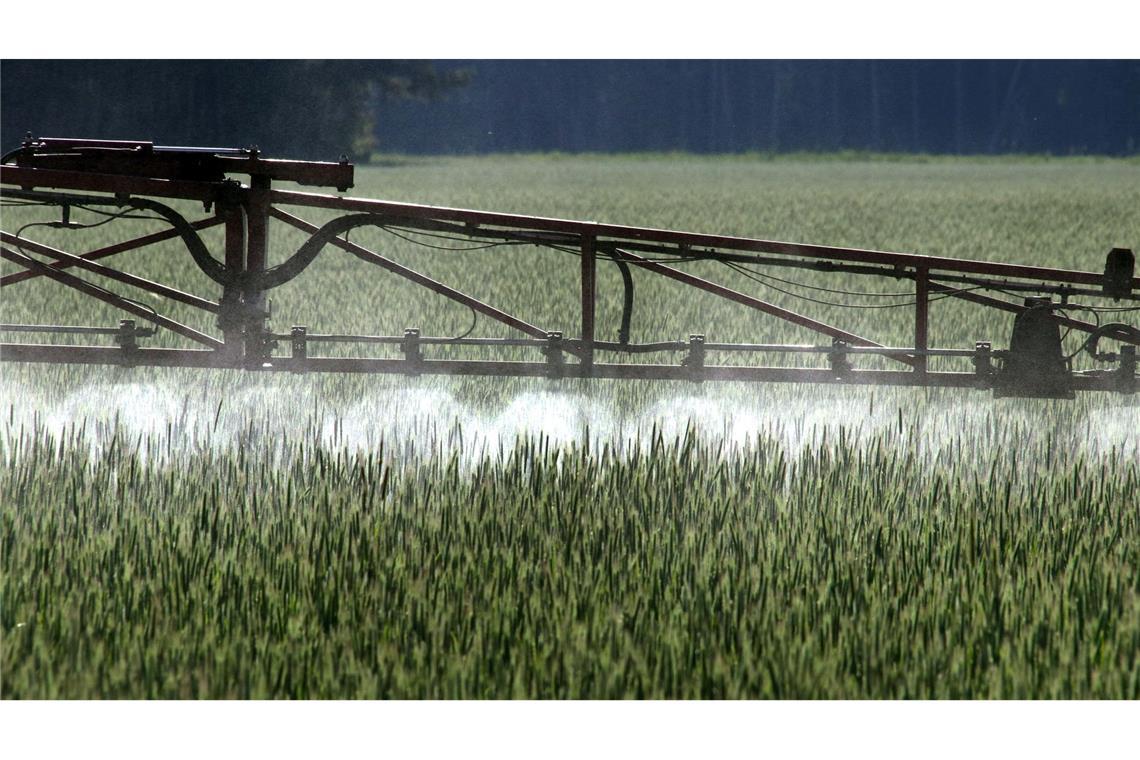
xmin=0 ymin=137 xmax=1140 ymax=398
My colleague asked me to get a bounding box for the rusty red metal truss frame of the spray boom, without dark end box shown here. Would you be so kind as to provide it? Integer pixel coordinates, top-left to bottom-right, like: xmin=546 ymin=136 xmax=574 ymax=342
xmin=0 ymin=139 xmax=1140 ymax=392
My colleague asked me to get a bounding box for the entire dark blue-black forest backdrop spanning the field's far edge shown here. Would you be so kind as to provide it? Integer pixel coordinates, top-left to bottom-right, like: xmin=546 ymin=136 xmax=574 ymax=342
xmin=0 ymin=60 xmax=1140 ymax=160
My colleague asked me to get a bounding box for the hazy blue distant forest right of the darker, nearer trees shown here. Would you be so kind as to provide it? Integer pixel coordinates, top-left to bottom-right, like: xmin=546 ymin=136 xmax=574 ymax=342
xmin=380 ymin=60 xmax=1140 ymax=154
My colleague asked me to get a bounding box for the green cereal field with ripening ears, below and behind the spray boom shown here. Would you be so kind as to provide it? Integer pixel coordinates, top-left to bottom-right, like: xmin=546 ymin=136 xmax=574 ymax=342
xmin=0 ymin=155 xmax=1140 ymax=700
